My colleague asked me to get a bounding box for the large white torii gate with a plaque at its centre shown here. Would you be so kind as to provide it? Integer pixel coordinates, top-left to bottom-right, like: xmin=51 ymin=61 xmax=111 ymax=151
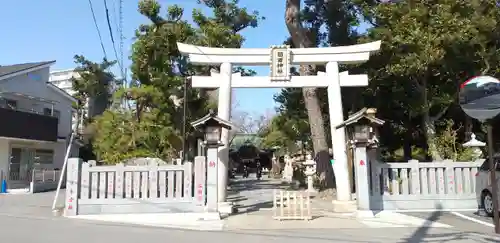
xmin=177 ymin=41 xmax=381 ymax=203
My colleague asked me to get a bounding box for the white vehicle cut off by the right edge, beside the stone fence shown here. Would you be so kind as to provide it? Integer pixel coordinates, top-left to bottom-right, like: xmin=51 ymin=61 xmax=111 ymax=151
xmin=476 ymin=159 xmax=500 ymax=217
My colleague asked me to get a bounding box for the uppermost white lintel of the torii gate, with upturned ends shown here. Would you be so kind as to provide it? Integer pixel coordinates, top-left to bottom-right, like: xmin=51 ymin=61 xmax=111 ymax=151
xmin=177 ymin=41 xmax=381 ymax=66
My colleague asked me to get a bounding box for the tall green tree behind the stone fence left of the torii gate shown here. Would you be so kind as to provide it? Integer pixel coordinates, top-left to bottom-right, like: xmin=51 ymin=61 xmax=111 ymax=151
xmin=91 ymin=0 xmax=259 ymax=161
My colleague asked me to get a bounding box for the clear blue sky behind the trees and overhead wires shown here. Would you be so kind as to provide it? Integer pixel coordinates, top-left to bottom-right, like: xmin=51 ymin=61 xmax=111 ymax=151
xmin=0 ymin=0 xmax=288 ymax=114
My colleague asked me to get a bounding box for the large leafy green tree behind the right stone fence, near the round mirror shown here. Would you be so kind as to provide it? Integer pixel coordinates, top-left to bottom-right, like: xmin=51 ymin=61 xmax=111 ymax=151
xmin=360 ymin=0 xmax=500 ymax=160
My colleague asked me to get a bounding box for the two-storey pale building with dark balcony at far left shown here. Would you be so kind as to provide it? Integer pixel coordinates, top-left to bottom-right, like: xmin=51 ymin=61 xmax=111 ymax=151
xmin=0 ymin=61 xmax=78 ymax=188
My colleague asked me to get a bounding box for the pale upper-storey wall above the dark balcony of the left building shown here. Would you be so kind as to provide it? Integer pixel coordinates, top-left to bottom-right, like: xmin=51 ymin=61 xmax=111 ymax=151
xmin=0 ymin=67 xmax=72 ymax=137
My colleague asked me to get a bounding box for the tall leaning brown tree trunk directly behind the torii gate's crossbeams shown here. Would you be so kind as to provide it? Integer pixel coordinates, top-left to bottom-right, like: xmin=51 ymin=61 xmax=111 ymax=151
xmin=285 ymin=0 xmax=335 ymax=189
